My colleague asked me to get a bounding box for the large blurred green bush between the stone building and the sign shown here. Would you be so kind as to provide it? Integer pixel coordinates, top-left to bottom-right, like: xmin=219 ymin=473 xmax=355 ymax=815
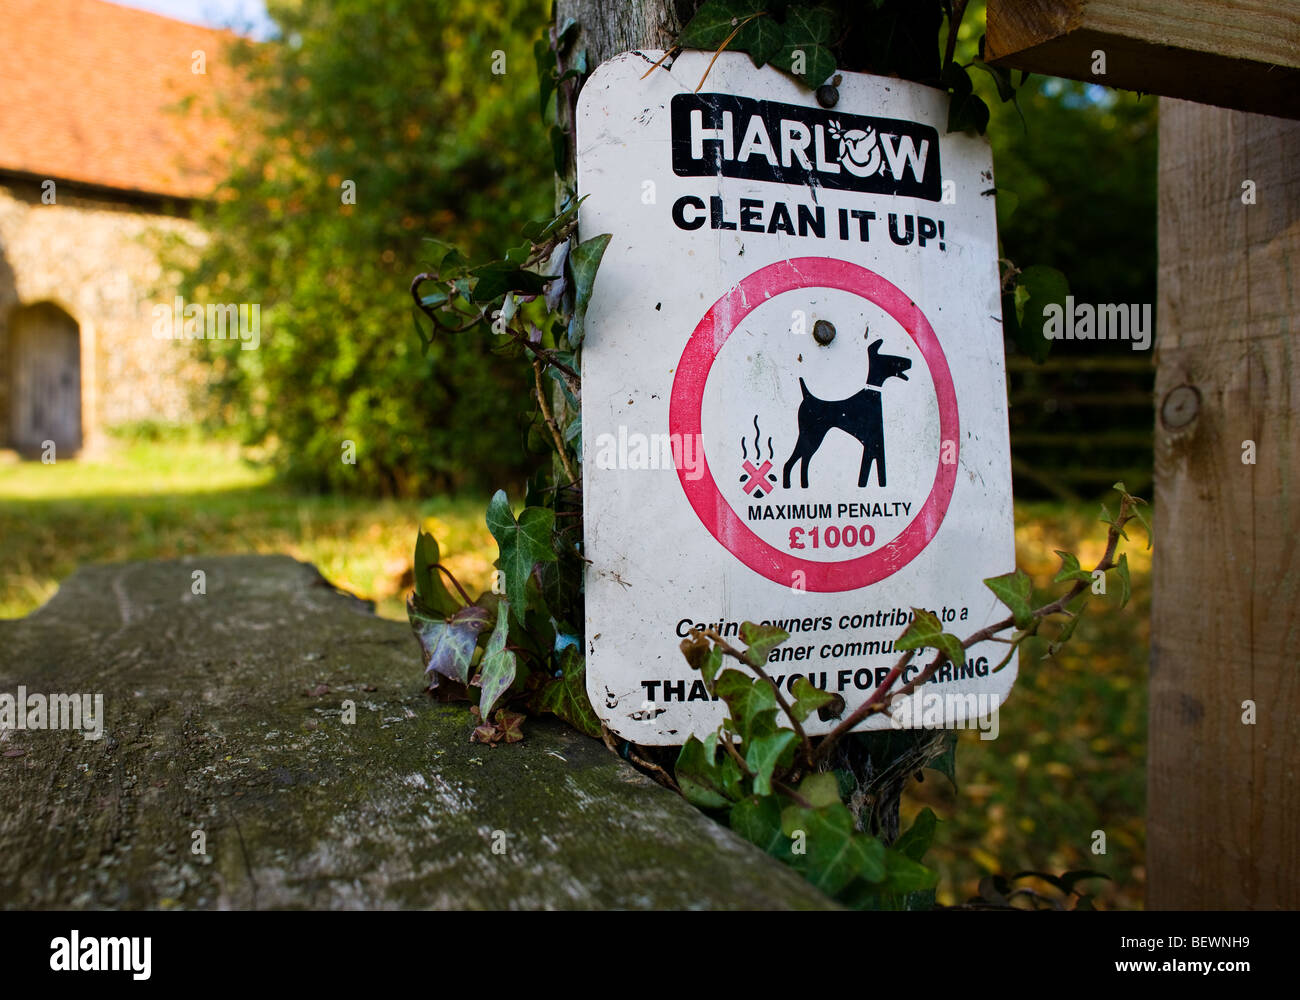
xmin=181 ymin=0 xmax=553 ymax=495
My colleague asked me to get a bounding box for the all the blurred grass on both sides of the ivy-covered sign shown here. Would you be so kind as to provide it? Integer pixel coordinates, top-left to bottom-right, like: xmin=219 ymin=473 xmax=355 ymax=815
xmin=0 ymin=441 xmax=1151 ymax=909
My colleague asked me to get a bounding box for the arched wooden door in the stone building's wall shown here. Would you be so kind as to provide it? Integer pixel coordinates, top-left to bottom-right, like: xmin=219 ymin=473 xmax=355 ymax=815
xmin=9 ymin=302 xmax=82 ymax=455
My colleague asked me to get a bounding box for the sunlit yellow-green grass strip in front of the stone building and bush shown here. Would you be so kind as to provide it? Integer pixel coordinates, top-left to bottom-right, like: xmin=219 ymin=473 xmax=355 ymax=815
xmin=0 ymin=441 xmax=495 ymax=620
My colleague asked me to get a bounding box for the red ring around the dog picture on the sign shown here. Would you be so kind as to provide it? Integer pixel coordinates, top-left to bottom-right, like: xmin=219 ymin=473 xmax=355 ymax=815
xmin=668 ymin=257 xmax=958 ymax=593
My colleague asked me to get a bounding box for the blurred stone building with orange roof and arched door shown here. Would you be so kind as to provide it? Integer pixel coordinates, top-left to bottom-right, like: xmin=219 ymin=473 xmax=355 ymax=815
xmin=0 ymin=0 xmax=235 ymax=456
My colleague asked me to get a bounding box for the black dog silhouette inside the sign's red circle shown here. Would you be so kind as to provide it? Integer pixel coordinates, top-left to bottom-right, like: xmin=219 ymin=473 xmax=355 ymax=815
xmin=783 ymin=339 xmax=911 ymax=489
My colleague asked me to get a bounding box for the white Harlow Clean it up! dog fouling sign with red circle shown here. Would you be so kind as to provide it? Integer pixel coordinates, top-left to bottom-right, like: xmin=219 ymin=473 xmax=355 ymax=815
xmin=577 ymin=52 xmax=1017 ymax=744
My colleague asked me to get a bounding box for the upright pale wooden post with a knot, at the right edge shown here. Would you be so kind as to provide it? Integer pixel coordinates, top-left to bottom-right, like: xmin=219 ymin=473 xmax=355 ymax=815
xmin=1148 ymin=100 xmax=1300 ymax=909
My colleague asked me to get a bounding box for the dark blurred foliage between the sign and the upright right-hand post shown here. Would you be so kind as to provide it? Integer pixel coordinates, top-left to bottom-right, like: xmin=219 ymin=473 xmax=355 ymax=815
xmin=956 ymin=0 xmax=1158 ymax=497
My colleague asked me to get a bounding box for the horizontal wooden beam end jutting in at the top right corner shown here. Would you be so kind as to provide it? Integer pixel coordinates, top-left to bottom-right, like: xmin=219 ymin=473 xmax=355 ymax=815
xmin=985 ymin=0 xmax=1300 ymax=118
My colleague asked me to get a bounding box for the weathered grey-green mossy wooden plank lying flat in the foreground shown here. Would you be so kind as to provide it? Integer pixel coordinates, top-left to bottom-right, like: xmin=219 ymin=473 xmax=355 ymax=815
xmin=0 ymin=557 xmax=832 ymax=909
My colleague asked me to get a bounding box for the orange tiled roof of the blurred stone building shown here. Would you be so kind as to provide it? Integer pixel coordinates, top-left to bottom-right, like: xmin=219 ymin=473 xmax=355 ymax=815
xmin=0 ymin=0 xmax=245 ymax=198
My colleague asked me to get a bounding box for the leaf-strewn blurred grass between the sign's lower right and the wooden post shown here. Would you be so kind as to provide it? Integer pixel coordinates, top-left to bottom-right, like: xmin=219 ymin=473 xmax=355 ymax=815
xmin=902 ymin=503 xmax=1152 ymax=909
